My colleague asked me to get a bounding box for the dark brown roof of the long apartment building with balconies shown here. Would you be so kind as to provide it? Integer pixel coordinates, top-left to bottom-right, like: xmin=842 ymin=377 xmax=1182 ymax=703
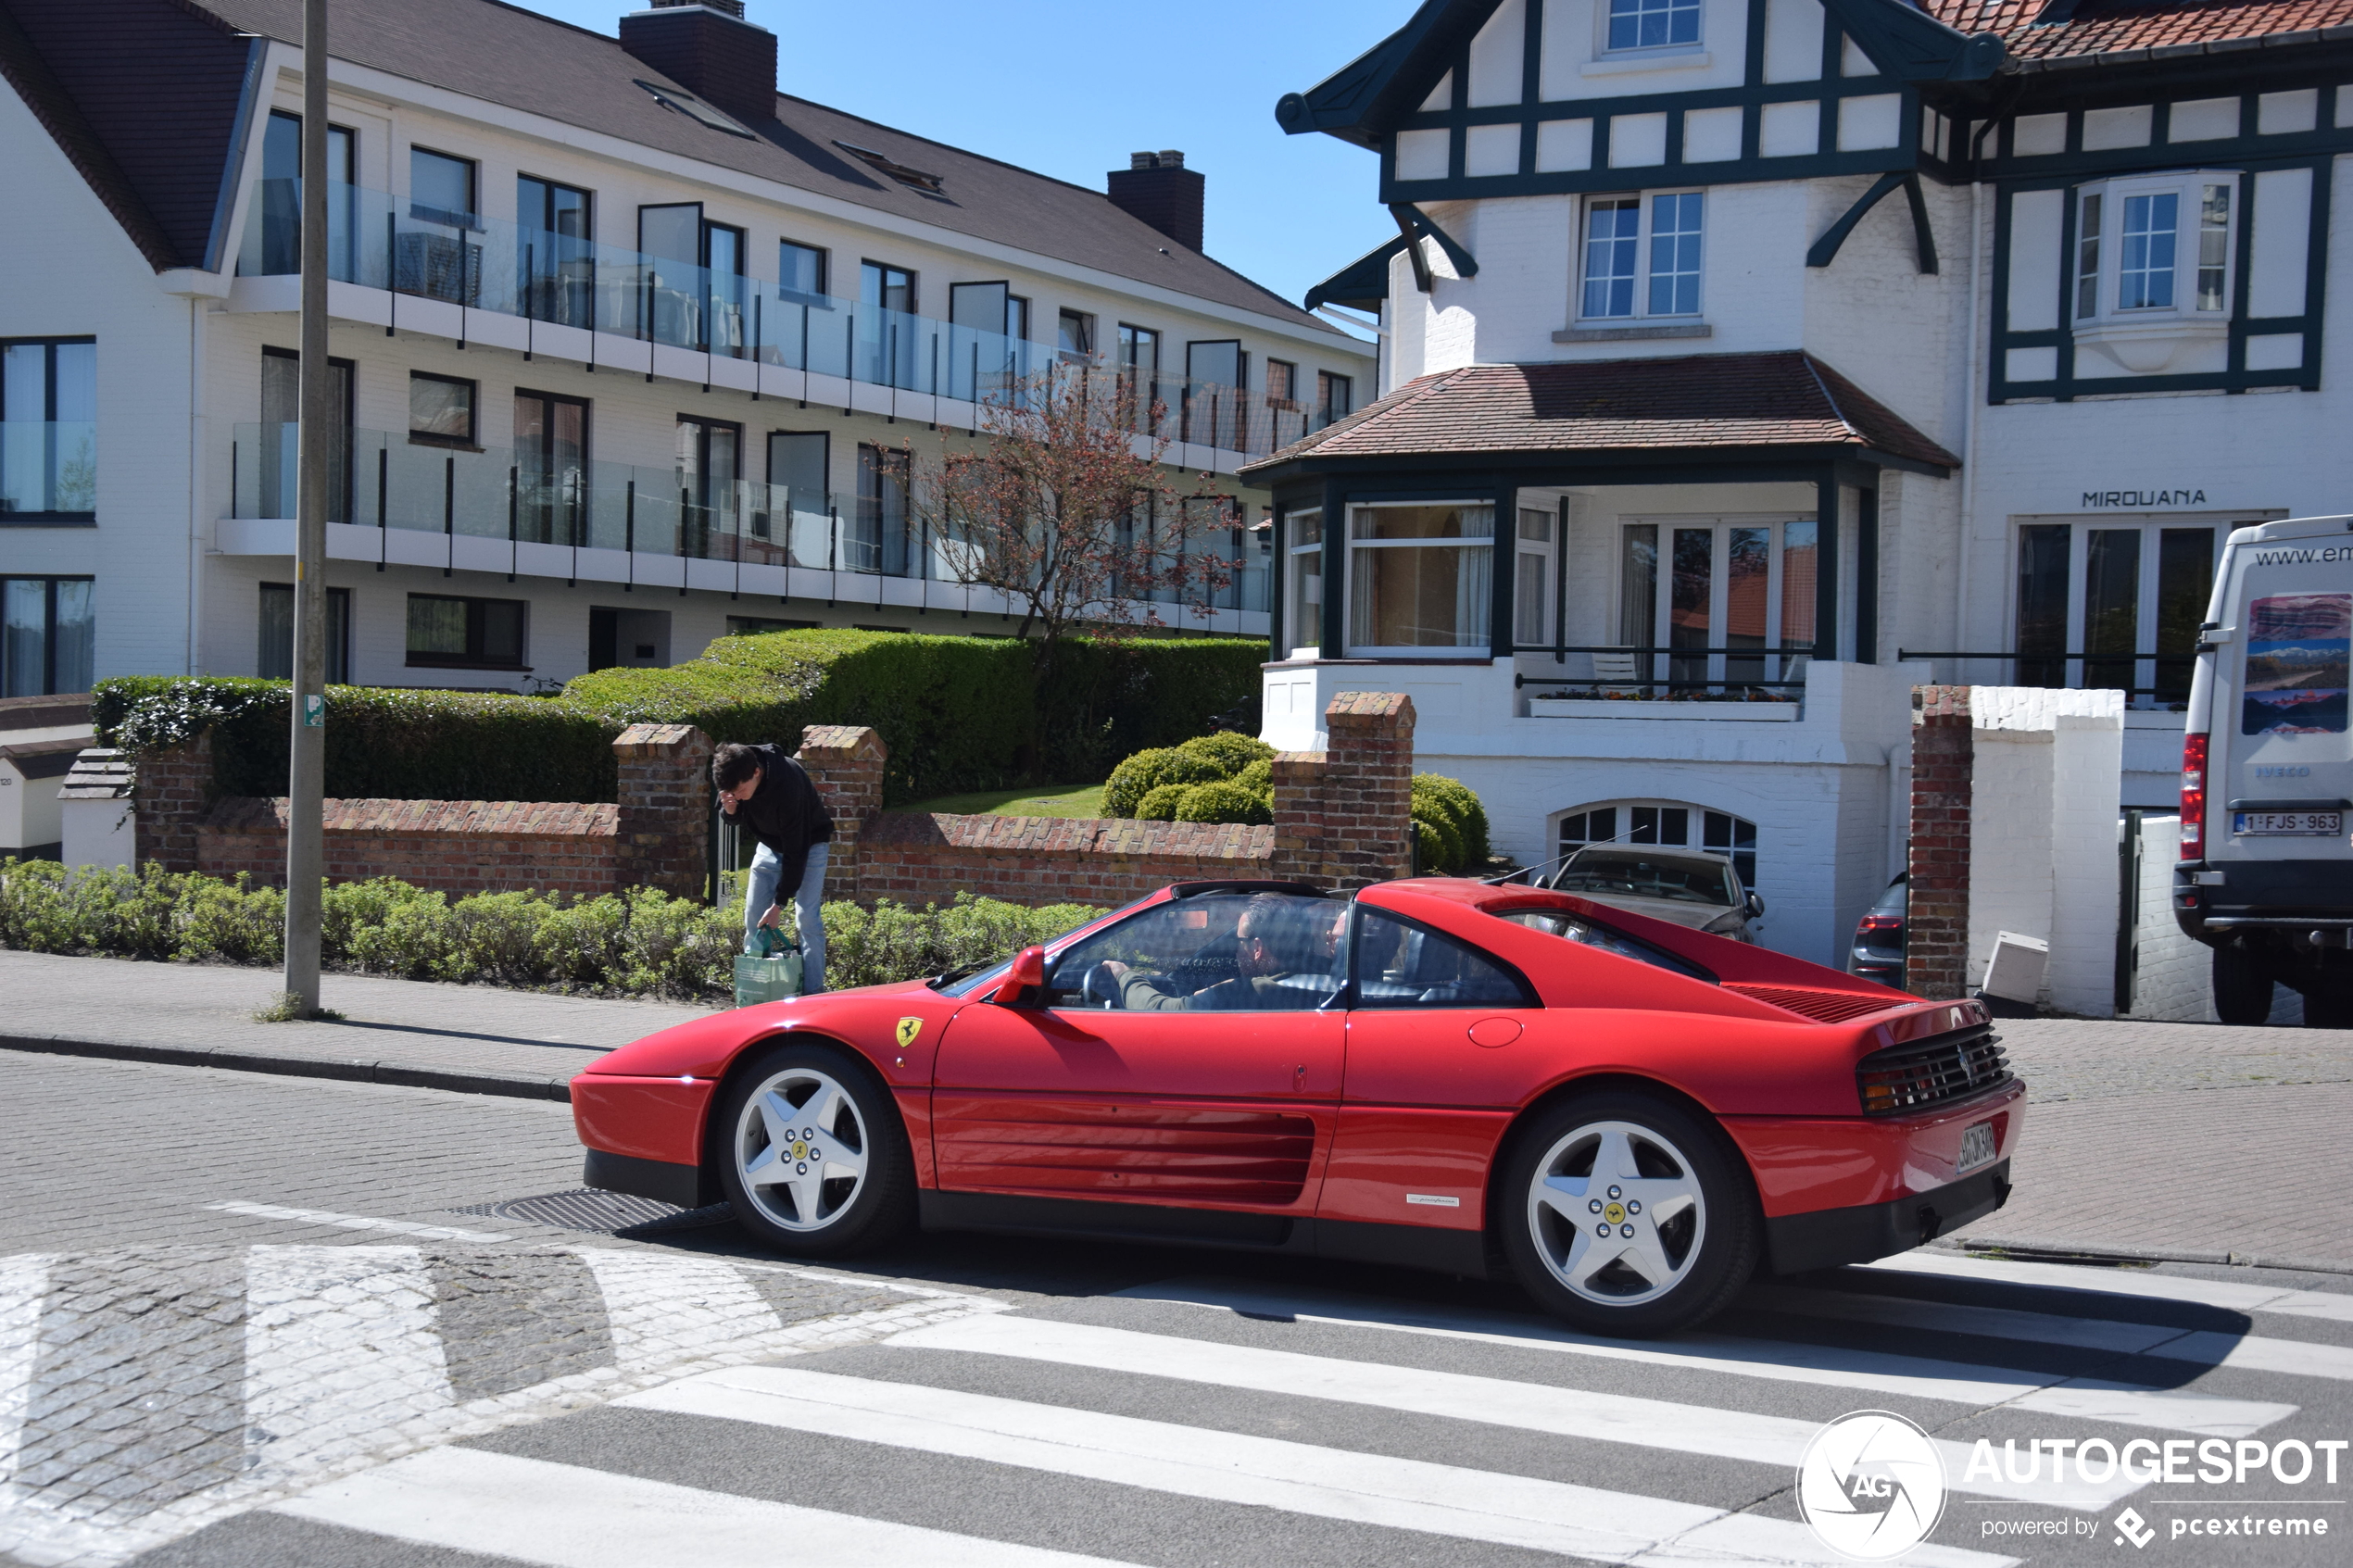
xmin=0 ymin=0 xmax=1346 ymax=333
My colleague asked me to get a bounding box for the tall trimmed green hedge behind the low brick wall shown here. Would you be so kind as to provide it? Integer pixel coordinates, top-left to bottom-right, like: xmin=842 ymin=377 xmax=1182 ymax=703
xmin=92 ymin=630 xmax=1266 ymax=804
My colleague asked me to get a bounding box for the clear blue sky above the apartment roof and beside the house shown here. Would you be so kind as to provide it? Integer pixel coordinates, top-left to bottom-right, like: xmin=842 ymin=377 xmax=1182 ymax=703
xmin=520 ymin=0 xmax=1415 ymax=321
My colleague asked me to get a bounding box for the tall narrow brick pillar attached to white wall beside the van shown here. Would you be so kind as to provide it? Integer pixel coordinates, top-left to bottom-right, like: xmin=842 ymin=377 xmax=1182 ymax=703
xmin=1904 ymin=686 xmax=1977 ymax=1001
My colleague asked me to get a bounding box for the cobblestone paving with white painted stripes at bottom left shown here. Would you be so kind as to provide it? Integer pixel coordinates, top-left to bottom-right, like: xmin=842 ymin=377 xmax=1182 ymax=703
xmin=0 ymin=1244 xmax=1000 ymax=1568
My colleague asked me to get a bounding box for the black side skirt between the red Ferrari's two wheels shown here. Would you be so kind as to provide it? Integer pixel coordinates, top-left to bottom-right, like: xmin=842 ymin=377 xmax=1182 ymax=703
xmin=918 ymin=1189 xmax=1487 ymax=1279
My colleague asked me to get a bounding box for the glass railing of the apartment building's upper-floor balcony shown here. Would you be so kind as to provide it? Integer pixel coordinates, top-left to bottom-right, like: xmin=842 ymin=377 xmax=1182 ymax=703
xmin=238 ymin=179 xmax=1365 ymax=454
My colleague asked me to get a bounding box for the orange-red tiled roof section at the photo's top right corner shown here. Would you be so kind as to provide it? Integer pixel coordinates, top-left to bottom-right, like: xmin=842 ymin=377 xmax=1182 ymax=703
xmin=1920 ymin=0 xmax=2353 ymax=70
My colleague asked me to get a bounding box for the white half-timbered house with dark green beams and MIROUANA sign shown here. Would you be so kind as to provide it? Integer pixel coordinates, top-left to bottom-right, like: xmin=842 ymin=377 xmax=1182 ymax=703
xmin=1242 ymin=0 xmax=2353 ymax=961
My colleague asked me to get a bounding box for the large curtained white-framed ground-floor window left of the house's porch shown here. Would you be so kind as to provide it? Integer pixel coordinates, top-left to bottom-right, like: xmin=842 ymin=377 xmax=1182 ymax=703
xmin=1348 ymin=501 xmax=1494 ymax=659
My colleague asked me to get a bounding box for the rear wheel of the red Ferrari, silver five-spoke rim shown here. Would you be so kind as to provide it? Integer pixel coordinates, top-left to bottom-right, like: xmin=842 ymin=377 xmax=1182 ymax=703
xmin=1494 ymin=1091 xmax=1762 ymax=1336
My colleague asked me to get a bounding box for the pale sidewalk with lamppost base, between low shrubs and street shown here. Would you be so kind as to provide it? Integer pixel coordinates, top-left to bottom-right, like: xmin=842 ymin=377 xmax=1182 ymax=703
xmin=0 ymin=952 xmax=711 ymax=1100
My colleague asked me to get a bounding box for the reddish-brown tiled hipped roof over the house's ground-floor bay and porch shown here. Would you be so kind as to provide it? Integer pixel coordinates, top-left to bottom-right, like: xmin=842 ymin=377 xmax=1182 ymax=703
xmin=1242 ymin=350 xmax=1960 ymax=477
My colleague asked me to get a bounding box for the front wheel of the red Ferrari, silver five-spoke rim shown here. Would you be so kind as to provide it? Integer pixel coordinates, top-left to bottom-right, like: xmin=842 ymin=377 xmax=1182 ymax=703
xmin=715 ymin=1041 xmax=915 ymax=1258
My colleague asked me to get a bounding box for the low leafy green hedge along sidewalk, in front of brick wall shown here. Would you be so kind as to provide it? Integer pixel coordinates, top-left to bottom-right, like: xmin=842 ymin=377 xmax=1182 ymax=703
xmin=0 ymin=860 xmax=1101 ymax=1001
